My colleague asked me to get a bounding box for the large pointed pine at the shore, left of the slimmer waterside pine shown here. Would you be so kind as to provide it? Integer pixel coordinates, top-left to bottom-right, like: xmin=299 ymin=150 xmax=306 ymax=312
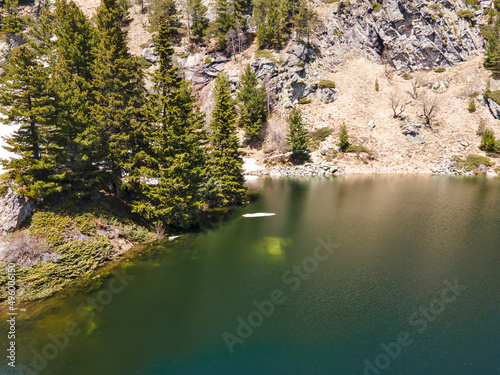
xmin=130 ymin=19 xmax=205 ymax=228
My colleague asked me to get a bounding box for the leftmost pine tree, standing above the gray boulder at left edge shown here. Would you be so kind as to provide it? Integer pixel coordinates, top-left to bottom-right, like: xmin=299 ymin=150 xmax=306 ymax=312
xmin=0 ymin=45 xmax=64 ymax=198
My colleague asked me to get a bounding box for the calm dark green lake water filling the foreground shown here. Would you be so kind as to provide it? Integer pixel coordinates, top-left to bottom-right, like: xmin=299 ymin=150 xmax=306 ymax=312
xmin=0 ymin=177 xmax=500 ymax=375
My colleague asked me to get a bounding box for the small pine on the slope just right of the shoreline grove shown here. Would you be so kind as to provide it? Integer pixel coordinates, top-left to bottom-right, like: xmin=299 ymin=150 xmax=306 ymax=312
xmin=238 ymin=64 xmax=267 ymax=138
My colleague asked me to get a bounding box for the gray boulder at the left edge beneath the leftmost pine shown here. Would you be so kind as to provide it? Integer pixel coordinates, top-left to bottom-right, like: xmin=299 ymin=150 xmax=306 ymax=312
xmin=0 ymin=188 xmax=35 ymax=236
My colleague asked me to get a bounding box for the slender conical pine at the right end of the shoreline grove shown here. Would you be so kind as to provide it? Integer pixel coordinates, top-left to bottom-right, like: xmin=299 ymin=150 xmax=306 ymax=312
xmin=208 ymin=74 xmax=247 ymax=207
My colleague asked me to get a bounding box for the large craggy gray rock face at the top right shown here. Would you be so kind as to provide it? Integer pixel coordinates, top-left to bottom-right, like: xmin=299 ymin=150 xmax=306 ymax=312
xmin=317 ymin=0 xmax=486 ymax=71
